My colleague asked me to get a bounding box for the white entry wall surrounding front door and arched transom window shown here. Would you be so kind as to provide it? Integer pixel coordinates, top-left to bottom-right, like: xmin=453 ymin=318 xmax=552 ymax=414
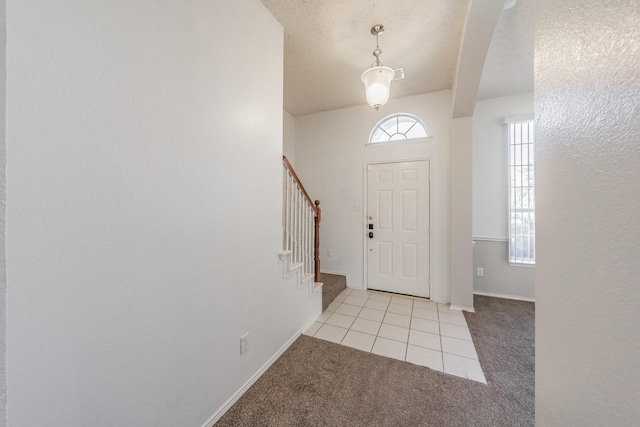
xmin=295 ymin=91 xmax=451 ymax=302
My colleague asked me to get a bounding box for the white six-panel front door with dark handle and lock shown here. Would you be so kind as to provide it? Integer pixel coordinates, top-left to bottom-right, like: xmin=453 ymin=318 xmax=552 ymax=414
xmin=365 ymin=160 xmax=429 ymax=298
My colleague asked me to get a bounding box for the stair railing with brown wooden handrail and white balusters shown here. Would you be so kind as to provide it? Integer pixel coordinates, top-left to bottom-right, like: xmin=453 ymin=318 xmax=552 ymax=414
xmin=282 ymin=156 xmax=320 ymax=282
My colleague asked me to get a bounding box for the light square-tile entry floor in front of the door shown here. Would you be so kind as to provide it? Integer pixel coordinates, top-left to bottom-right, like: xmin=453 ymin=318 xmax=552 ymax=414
xmin=305 ymin=289 xmax=487 ymax=384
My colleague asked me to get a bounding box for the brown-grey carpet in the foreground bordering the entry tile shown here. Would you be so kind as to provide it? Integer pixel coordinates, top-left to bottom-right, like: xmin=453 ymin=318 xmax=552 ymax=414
xmin=216 ymin=296 xmax=535 ymax=427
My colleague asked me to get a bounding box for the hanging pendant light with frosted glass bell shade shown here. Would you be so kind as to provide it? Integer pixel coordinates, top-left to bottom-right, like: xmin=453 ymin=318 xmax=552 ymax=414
xmin=360 ymin=24 xmax=404 ymax=111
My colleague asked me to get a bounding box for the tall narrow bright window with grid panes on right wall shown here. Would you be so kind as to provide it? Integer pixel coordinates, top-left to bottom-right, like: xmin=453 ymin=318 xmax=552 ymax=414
xmin=505 ymin=119 xmax=536 ymax=265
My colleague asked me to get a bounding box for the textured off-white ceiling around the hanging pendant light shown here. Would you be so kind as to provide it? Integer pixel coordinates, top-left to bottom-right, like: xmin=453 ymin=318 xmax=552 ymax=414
xmin=262 ymin=0 xmax=533 ymax=116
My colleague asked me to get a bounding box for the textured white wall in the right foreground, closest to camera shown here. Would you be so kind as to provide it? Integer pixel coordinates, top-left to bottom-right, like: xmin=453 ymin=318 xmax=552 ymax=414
xmin=535 ymin=0 xmax=640 ymax=426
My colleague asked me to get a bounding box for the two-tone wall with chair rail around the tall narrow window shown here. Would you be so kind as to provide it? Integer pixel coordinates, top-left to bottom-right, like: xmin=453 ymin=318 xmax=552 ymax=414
xmin=473 ymin=93 xmax=535 ymax=299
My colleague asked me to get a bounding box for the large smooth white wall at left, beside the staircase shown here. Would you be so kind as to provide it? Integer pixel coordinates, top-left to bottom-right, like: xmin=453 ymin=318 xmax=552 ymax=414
xmin=7 ymin=0 xmax=310 ymax=427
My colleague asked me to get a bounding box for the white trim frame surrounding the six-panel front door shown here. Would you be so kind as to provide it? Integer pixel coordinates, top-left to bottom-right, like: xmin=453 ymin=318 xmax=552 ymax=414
xmin=362 ymin=156 xmax=433 ymax=298
